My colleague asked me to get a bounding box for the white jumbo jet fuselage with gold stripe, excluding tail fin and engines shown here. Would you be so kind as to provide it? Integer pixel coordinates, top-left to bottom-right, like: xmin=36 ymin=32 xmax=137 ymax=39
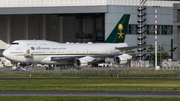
xmin=3 ymin=40 xmax=127 ymax=64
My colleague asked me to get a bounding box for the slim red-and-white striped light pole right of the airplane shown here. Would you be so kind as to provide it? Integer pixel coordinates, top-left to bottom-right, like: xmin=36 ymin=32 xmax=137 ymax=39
xmin=153 ymin=6 xmax=160 ymax=70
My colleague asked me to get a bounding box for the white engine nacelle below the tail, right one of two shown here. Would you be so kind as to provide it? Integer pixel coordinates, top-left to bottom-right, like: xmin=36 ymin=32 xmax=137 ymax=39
xmin=114 ymin=56 xmax=128 ymax=65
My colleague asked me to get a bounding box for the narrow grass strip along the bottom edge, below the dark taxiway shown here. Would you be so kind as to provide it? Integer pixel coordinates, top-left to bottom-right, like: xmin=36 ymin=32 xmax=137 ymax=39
xmin=0 ymin=96 xmax=180 ymax=101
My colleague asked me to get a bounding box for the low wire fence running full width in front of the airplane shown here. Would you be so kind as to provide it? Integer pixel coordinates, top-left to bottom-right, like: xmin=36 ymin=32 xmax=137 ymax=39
xmin=0 ymin=67 xmax=180 ymax=77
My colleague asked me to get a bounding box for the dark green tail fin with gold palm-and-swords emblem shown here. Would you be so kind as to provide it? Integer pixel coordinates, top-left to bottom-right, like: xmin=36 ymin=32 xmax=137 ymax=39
xmin=104 ymin=14 xmax=130 ymax=43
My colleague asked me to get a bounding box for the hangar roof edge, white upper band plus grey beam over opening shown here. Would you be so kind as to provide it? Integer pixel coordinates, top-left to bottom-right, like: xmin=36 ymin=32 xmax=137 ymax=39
xmin=0 ymin=0 xmax=180 ymax=15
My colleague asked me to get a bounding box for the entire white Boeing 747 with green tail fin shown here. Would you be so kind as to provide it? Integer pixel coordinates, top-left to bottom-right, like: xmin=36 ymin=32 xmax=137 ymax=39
xmin=3 ymin=14 xmax=149 ymax=67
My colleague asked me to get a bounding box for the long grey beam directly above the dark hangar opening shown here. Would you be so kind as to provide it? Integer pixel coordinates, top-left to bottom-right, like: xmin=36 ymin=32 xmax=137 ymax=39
xmin=0 ymin=6 xmax=108 ymax=15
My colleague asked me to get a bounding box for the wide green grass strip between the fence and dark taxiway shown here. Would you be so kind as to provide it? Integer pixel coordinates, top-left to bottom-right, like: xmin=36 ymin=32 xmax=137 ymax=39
xmin=0 ymin=79 xmax=180 ymax=92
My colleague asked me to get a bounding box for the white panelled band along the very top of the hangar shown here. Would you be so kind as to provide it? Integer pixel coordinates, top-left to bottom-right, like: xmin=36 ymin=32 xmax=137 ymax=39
xmin=0 ymin=0 xmax=180 ymax=7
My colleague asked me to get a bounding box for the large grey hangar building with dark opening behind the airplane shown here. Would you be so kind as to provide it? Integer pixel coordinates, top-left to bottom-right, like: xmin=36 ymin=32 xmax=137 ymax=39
xmin=0 ymin=0 xmax=180 ymax=59
